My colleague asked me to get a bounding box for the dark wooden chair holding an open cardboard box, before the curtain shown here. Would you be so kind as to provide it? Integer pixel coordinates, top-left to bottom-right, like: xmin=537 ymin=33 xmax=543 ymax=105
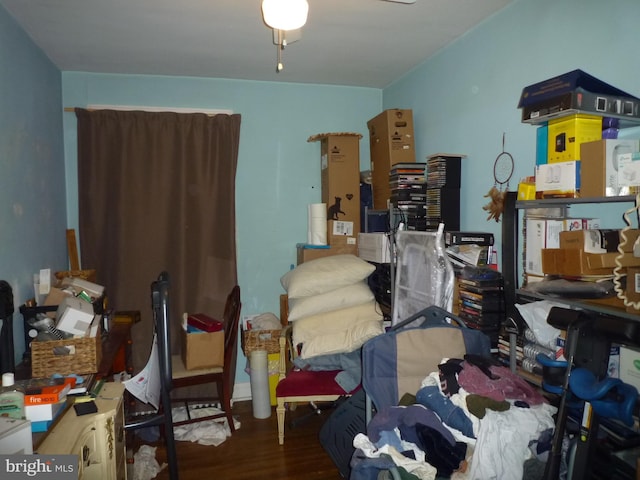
xmin=171 ymin=285 xmax=242 ymax=432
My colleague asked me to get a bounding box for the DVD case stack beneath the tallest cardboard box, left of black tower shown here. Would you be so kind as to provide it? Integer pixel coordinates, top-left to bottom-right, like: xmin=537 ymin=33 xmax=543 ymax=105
xmin=389 ymin=163 xmax=427 ymax=231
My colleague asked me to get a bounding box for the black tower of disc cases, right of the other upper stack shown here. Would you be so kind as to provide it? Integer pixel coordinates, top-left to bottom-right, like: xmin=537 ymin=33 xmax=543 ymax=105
xmin=426 ymin=154 xmax=463 ymax=230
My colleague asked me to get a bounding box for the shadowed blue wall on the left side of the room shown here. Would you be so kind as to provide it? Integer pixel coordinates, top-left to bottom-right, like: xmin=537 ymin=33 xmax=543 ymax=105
xmin=0 ymin=7 xmax=68 ymax=361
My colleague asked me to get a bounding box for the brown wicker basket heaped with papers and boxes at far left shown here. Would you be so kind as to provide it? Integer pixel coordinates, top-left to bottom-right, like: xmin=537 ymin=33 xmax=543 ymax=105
xmin=31 ymin=332 xmax=102 ymax=378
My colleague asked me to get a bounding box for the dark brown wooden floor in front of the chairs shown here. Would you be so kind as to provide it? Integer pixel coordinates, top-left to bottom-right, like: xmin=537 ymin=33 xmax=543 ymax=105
xmin=137 ymin=402 xmax=342 ymax=480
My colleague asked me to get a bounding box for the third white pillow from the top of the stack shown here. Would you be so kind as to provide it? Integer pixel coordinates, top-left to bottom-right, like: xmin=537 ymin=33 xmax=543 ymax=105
xmin=292 ymin=300 xmax=382 ymax=345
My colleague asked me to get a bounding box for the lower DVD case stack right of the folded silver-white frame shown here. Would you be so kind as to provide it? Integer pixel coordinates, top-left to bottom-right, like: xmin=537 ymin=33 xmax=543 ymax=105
xmin=458 ymin=276 xmax=505 ymax=353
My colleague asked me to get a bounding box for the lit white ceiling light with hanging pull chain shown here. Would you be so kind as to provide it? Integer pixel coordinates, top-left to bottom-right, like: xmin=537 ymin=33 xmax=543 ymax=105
xmin=262 ymin=0 xmax=309 ymax=73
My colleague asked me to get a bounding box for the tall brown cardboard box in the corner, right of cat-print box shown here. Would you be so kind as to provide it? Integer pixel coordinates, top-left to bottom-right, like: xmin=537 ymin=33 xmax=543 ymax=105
xmin=367 ymin=109 xmax=416 ymax=210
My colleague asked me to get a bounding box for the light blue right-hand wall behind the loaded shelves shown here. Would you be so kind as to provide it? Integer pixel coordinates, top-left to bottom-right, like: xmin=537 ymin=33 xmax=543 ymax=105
xmin=383 ymin=0 xmax=640 ymax=248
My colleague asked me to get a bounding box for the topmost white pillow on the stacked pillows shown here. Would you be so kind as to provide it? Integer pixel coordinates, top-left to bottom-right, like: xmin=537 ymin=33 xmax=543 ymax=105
xmin=280 ymin=255 xmax=376 ymax=298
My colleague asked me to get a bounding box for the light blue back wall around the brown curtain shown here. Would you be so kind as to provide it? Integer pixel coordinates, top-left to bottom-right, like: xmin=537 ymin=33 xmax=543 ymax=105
xmin=62 ymin=72 xmax=382 ymax=382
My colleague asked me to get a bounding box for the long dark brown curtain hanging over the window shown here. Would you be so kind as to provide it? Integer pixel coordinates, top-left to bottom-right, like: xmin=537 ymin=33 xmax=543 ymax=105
xmin=76 ymin=109 xmax=240 ymax=371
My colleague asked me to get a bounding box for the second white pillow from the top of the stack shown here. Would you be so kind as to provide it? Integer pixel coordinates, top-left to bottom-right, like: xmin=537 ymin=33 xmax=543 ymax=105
xmin=287 ymin=280 xmax=375 ymax=322
